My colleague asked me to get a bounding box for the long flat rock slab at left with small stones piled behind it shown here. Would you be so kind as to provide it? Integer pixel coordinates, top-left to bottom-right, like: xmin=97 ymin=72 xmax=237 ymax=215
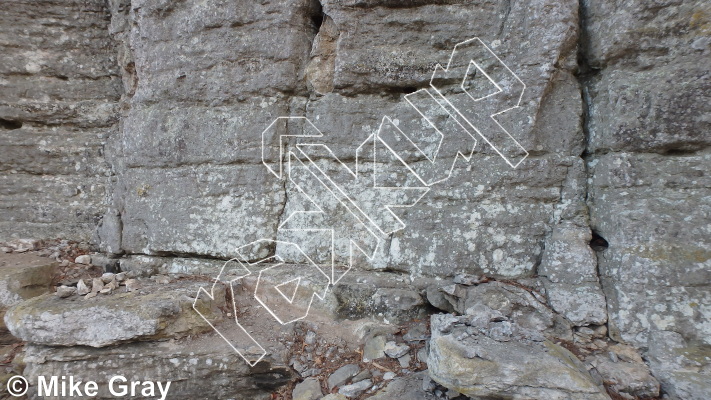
xmin=5 ymin=281 xmax=225 ymax=347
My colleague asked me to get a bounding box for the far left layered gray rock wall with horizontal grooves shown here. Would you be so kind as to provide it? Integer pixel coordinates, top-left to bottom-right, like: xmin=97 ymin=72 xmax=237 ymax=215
xmin=0 ymin=1 xmax=121 ymax=241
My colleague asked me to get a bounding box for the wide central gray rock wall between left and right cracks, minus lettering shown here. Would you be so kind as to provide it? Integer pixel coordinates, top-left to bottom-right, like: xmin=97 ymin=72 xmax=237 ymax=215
xmin=102 ymin=1 xmax=584 ymax=277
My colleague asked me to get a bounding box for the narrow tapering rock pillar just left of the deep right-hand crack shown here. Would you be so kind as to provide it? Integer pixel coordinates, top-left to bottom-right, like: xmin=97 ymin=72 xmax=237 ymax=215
xmin=537 ymin=0 xmax=608 ymax=326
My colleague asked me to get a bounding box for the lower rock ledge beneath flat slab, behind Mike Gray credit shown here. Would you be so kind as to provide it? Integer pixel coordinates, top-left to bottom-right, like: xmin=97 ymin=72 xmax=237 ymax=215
xmin=24 ymin=335 xmax=292 ymax=400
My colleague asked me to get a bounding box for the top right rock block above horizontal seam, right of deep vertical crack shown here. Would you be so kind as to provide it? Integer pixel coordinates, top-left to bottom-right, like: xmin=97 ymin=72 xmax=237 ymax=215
xmin=583 ymin=0 xmax=711 ymax=153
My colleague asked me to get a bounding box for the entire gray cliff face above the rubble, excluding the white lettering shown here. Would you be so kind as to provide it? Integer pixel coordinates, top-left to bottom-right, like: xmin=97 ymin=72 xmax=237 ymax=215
xmin=0 ymin=0 xmax=711 ymax=399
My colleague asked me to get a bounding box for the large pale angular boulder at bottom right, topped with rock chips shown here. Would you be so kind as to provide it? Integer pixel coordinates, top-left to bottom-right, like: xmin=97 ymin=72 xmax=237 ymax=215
xmin=427 ymin=310 xmax=609 ymax=400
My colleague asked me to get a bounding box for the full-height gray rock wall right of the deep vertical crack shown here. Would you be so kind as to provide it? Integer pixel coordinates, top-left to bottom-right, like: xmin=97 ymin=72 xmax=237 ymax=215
xmin=582 ymin=1 xmax=711 ymax=398
